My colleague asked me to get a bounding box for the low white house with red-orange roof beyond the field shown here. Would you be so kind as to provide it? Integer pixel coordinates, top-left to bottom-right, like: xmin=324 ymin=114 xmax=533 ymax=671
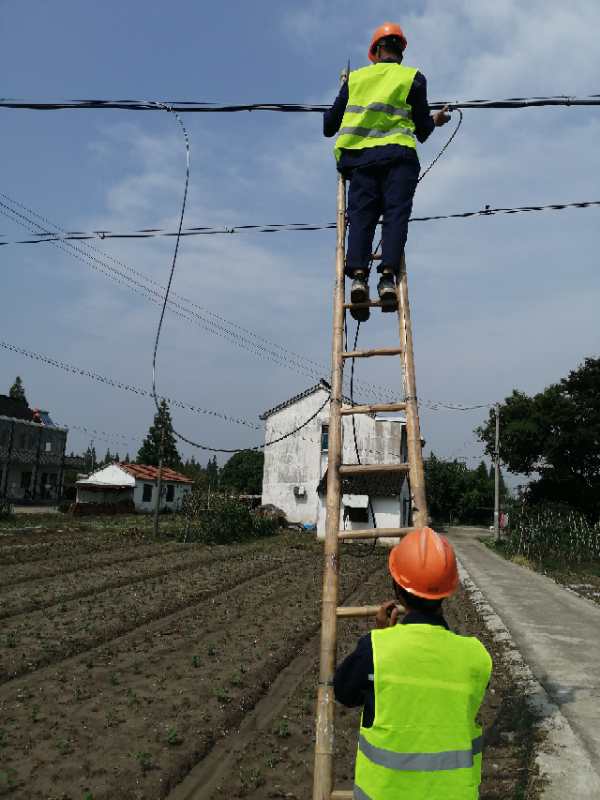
xmin=75 ymin=463 xmax=193 ymax=511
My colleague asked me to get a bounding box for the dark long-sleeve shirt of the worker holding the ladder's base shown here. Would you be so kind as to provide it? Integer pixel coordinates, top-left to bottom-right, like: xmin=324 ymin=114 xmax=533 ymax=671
xmin=333 ymin=611 xmax=449 ymax=728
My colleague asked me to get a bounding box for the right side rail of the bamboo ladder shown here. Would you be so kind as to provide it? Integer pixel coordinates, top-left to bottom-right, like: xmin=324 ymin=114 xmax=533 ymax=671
xmin=397 ymin=256 xmax=429 ymax=528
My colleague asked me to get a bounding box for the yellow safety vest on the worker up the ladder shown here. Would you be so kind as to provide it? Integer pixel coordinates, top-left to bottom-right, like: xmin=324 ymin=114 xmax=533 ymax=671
xmin=334 ymin=62 xmax=417 ymax=161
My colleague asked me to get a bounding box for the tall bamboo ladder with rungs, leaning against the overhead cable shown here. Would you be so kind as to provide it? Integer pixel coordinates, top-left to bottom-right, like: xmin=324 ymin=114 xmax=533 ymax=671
xmin=313 ymin=169 xmax=427 ymax=800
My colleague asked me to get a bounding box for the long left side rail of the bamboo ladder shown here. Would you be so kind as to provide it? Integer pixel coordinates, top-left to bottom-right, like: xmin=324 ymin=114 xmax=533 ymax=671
xmin=313 ymin=170 xmax=346 ymax=800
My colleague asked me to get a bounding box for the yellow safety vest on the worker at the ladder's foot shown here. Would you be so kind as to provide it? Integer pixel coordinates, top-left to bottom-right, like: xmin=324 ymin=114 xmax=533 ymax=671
xmin=354 ymin=625 xmax=492 ymax=800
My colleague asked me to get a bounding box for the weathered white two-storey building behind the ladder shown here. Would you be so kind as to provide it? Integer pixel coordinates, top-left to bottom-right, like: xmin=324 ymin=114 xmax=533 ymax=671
xmin=261 ymin=381 xmax=410 ymax=536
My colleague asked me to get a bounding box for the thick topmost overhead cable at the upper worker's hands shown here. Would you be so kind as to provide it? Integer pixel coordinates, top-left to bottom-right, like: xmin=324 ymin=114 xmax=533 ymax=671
xmin=0 ymin=94 xmax=600 ymax=114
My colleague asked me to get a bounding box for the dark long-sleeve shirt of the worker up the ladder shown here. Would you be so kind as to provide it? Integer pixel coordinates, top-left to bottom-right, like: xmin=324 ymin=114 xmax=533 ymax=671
xmin=323 ymin=59 xmax=435 ymax=174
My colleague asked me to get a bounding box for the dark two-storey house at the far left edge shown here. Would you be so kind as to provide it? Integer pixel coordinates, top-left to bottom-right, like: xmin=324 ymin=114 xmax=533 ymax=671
xmin=0 ymin=395 xmax=67 ymax=503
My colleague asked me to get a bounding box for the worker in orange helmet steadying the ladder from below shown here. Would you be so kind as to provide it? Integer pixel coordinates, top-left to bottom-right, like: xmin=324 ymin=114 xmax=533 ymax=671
xmin=334 ymin=528 xmax=492 ymax=800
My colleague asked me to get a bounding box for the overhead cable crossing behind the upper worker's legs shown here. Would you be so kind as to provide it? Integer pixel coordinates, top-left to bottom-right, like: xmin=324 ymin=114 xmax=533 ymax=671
xmin=0 ymin=192 xmax=600 ymax=245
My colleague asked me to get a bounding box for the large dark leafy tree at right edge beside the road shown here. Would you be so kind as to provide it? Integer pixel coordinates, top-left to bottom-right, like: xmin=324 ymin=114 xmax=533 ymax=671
xmin=476 ymin=358 xmax=600 ymax=517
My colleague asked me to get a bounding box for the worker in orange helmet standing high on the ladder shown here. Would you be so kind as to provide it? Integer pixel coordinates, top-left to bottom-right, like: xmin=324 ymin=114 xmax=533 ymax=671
xmin=323 ymin=22 xmax=450 ymax=321
